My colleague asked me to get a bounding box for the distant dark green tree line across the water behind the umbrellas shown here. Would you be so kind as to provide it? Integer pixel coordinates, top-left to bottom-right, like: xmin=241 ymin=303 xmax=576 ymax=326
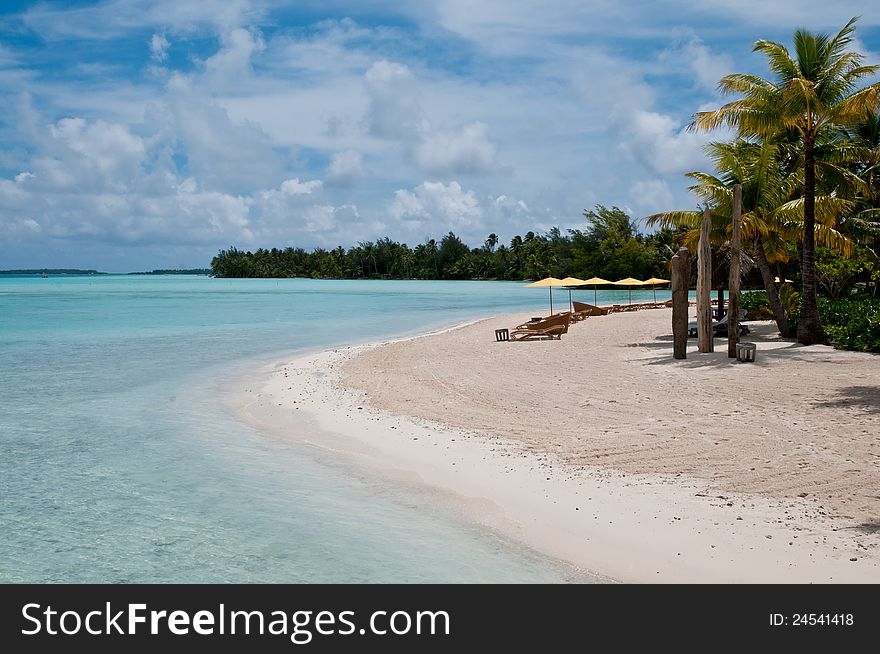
xmin=211 ymin=205 xmax=677 ymax=280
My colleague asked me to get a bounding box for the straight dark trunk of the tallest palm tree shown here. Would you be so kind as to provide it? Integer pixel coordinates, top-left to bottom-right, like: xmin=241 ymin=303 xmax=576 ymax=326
xmin=798 ymin=136 xmax=825 ymax=345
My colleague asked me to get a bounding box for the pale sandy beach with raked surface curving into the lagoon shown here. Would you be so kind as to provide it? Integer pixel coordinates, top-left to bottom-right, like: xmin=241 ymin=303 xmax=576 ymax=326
xmin=242 ymin=309 xmax=880 ymax=583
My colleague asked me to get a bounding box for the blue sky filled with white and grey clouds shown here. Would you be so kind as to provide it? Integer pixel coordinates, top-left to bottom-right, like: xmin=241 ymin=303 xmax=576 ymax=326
xmin=0 ymin=0 xmax=880 ymax=272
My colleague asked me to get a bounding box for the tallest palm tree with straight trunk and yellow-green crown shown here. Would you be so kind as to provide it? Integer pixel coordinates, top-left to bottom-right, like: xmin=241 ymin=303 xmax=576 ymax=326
xmin=691 ymin=18 xmax=880 ymax=344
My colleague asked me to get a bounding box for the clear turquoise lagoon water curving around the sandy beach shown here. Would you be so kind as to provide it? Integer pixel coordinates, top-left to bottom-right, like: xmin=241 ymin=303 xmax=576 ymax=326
xmin=0 ymin=276 xmax=668 ymax=583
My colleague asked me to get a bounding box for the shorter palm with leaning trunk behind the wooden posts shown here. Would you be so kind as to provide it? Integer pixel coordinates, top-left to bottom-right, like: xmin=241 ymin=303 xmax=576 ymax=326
xmin=648 ymin=139 xmax=853 ymax=335
